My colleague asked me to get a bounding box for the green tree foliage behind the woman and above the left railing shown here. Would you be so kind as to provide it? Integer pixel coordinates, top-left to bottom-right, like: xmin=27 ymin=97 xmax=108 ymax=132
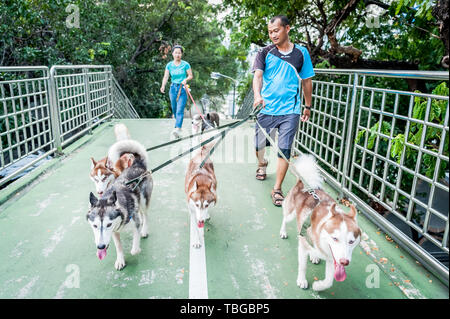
xmin=0 ymin=0 xmax=246 ymax=117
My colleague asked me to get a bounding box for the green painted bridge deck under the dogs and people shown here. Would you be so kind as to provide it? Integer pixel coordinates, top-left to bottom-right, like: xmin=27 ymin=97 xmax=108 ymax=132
xmin=0 ymin=120 xmax=448 ymax=299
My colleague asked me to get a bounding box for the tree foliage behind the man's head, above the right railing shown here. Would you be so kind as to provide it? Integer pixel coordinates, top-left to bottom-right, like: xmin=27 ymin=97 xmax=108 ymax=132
xmin=223 ymin=0 xmax=448 ymax=70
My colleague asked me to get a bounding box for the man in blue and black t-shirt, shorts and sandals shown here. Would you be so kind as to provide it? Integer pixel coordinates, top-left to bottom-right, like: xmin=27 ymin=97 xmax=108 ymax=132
xmin=252 ymin=15 xmax=314 ymax=206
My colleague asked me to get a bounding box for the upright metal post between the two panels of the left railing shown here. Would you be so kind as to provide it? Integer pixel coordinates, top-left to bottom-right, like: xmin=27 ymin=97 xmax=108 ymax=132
xmin=47 ymin=67 xmax=64 ymax=156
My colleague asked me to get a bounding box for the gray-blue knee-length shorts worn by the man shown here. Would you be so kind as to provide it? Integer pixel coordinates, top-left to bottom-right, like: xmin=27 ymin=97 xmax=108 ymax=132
xmin=255 ymin=113 xmax=300 ymax=159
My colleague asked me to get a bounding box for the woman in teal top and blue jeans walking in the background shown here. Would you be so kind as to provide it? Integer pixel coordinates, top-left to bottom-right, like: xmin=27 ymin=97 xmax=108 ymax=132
xmin=160 ymin=45 xmax=193 ymax=138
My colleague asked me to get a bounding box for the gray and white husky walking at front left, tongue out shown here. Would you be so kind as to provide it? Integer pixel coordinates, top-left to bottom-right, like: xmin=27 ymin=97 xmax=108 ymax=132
xmin=86 ymin=159 xmax=153 ymax=270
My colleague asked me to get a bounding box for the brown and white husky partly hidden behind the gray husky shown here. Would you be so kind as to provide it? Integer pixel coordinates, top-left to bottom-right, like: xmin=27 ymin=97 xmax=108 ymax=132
xmin=89 ymin=123 xmax=147 ymax=197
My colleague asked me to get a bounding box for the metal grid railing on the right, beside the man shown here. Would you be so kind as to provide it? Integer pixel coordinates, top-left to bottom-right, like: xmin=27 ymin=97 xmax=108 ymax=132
xmin=293 ymin=69 xmax=449 ymax=285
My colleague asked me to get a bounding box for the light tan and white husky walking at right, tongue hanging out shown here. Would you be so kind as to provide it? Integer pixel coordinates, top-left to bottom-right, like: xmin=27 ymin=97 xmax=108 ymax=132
xmin=280 ymin=155 xmax=361 ymax=291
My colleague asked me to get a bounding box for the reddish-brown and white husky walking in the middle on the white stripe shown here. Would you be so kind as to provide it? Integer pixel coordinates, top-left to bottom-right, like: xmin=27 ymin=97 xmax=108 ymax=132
xmin=185 ymin=144 xmax=217 ymax=248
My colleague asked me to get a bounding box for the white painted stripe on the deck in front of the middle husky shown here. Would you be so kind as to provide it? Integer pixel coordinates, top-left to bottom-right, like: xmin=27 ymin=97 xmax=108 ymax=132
xmin=189 ymin=220 xmax=208 ymax=299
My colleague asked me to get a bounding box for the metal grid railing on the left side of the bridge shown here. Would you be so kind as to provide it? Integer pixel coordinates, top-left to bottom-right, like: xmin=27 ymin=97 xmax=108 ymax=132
xmin=0 ymin=65 xmax=139 ymax=186
